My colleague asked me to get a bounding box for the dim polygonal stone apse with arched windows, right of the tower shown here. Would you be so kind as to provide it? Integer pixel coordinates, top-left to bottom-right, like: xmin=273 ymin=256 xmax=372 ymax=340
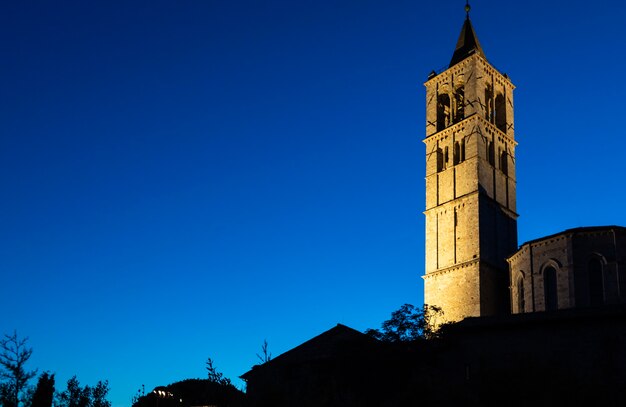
xmin=508 ymin=226 xmax=626 ymax=314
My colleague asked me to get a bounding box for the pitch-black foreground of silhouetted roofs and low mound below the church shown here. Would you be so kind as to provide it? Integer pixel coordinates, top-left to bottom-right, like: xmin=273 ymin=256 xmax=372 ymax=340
xmin=135 ymin=306 xmax=626 ymax=407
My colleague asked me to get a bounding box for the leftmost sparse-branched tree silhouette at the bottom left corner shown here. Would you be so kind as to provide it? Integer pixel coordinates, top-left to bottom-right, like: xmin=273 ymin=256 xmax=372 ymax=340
xmin=0 ymin=331 xmax=37 ymax=407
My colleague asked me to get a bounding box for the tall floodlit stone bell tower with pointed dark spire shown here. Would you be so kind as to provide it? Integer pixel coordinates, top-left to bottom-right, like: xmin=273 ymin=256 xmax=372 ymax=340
xmin=424 ymin=5 xmax=518 ymax=321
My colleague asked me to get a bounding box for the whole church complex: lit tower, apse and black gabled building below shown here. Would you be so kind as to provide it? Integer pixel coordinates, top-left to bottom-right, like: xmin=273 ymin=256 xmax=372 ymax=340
xmin=241 ymin=5 xmax=626 ymax=407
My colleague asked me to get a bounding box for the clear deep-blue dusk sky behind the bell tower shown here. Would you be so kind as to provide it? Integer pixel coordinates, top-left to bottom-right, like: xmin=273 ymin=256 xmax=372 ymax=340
xmin=0 ymin=0 xmax=626 ymax=407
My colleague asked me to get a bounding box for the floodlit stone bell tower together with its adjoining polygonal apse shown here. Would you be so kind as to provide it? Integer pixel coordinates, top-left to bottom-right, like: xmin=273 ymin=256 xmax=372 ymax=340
xmin=424 ymin=5 xmax=626 ymax=321
